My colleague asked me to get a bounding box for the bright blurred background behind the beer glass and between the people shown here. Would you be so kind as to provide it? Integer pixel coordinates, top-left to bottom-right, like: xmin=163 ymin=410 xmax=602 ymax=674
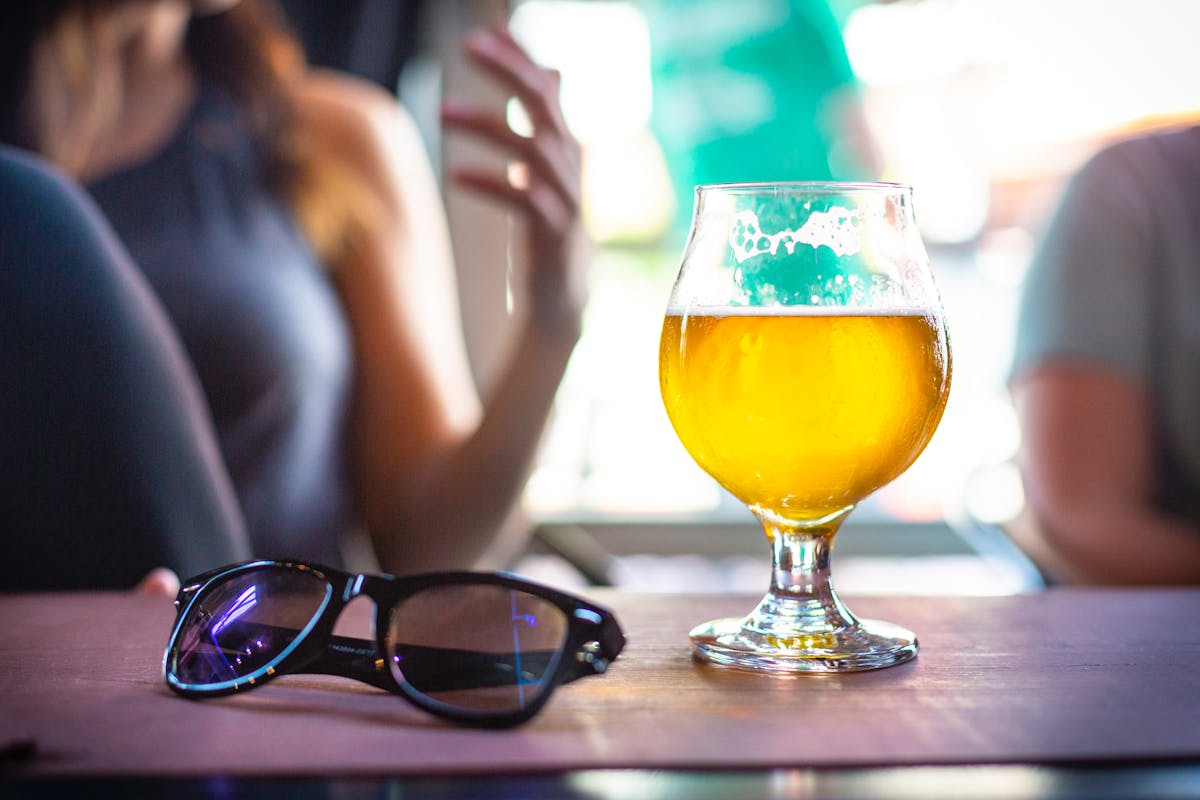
xmin=290 ymin=0 xmax=1200 ymax=594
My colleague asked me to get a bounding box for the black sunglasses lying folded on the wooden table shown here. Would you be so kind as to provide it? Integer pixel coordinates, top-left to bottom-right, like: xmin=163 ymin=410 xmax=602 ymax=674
xmin=163 ymin=561 xmax=625 ymax=726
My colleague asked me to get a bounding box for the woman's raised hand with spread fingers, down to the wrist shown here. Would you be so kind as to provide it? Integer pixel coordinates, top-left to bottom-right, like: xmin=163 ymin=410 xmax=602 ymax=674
xmin=442 ymin=25 xmax=587 ymax=337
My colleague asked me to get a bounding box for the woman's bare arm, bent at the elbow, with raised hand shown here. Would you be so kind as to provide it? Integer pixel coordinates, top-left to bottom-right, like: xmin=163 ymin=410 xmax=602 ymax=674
xmin=300 ymin=26 xmax=586 ymax=572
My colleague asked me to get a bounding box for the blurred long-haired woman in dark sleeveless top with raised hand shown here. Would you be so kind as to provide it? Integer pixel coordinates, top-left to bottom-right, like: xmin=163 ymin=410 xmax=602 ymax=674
xmin=0 ymin=0 xmax=584 ymax=587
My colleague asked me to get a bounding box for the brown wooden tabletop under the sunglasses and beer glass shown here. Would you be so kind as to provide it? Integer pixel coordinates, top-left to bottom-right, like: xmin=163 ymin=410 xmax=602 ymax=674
xmin=0 ymin=589 xmax=1200 ymax=798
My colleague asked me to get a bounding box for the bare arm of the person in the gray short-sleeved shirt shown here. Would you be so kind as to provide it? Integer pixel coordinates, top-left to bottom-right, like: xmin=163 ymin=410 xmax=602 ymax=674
xmin=1013 ymin=363 xmax=1200 ymax=584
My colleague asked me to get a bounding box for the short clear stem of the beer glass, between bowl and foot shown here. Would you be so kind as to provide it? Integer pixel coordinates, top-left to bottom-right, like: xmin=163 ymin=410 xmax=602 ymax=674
xmin=744 ymin=509 xmax=858 ymax=637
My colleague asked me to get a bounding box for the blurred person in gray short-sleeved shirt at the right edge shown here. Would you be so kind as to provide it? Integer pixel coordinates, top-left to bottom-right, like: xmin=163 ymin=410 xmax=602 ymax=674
xmin=1010 ymin=127 xmax=1200 ymax=584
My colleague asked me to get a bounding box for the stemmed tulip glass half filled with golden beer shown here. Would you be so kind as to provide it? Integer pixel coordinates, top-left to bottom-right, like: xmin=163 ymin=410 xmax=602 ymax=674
xmin=659 ymin=182 xmax=950 ymax=673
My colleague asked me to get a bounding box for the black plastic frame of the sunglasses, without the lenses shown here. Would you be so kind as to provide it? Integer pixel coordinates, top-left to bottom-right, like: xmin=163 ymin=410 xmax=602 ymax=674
xmin=162 ymin=559 xmax=625 ymax=727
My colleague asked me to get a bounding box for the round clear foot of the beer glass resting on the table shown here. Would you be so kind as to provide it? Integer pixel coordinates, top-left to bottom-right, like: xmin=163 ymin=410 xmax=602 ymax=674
xmin=689 ymin=618 xmax=917 ymax=674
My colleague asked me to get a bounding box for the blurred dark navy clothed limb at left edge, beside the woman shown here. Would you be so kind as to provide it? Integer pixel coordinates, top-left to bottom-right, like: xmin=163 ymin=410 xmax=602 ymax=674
xmin=0 ymin=146 xmax=251 ymax=593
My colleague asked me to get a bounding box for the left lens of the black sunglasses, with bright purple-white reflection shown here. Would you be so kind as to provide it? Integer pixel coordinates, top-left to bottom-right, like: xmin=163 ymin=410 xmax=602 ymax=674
xmin=167 ymin=565 xmax=332 ymax=690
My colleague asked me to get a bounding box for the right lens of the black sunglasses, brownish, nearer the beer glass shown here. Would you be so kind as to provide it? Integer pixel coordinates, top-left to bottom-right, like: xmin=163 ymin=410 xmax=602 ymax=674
xmin=388 ymin=584 xmax=568 ymax=715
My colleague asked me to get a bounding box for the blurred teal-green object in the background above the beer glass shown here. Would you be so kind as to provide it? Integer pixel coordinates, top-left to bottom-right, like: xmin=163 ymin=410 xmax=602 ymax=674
xmin=646 ymin=0 xmax=870 ymax=235
